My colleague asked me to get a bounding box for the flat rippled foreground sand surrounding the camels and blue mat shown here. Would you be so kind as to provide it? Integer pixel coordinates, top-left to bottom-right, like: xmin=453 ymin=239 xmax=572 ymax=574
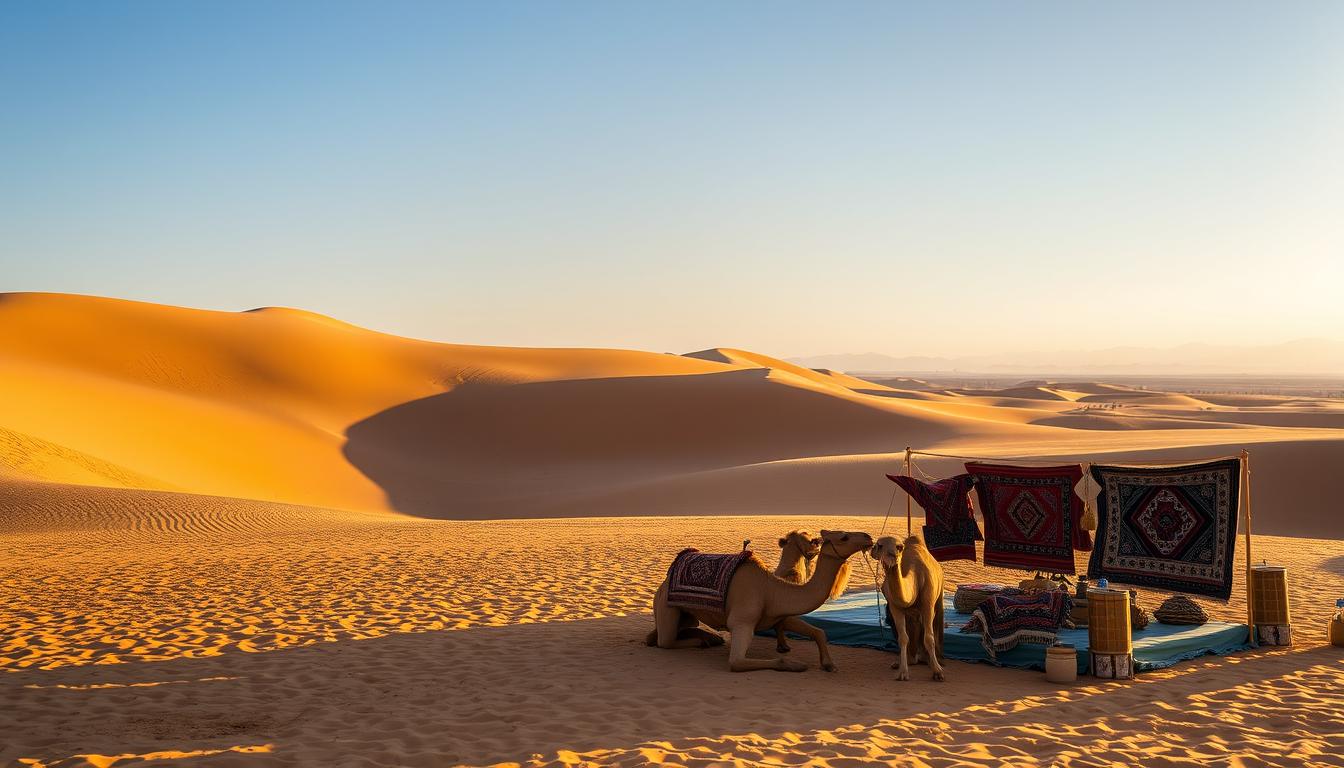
xmin=0 ymin=484 xmax=1344 ymax=767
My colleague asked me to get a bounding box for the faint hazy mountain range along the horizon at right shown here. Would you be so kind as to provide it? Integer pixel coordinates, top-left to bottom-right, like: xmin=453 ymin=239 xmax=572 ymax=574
xmin=789 ymin=339 xmax=1344 ymax=375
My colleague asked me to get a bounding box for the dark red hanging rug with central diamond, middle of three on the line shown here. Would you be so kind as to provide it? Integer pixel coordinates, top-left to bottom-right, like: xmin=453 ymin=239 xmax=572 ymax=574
xmin=966 ymin=463 xmax=1091 ymax=573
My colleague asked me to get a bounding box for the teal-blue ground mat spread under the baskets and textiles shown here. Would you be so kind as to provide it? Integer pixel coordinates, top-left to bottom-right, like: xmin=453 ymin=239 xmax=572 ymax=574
xmin=784 ymin=592 xmax=1250 ymax=673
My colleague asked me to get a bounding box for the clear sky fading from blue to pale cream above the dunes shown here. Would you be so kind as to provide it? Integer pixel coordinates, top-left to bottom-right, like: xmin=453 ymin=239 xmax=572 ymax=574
xmin=0 ymin=0 xmax=1344 ymax=356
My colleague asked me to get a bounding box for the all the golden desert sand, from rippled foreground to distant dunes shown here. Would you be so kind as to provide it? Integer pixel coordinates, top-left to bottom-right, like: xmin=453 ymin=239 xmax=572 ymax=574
xmin=0 ymin=295 xmax=1344 ymax=767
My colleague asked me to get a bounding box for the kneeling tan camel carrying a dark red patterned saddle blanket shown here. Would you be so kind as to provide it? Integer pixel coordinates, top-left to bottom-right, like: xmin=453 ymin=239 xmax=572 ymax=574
xmin=646 ymin=531 xmax=872 ymax=673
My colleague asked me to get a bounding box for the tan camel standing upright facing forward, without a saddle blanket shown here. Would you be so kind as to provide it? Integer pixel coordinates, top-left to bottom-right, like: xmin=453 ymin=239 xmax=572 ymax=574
xmin=871 ymin=537 xmax=945 ymax=681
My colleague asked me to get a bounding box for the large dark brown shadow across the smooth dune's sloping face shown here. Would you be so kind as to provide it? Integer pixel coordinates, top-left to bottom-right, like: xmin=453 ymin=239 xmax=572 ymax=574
xmin=343 ymin=369 xmax=953 ymax=519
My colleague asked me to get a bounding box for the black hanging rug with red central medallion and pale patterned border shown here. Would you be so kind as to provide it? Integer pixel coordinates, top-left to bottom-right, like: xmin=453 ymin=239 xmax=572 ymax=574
xmin=1087 ymin=459 xmax=1241 ymax=600
